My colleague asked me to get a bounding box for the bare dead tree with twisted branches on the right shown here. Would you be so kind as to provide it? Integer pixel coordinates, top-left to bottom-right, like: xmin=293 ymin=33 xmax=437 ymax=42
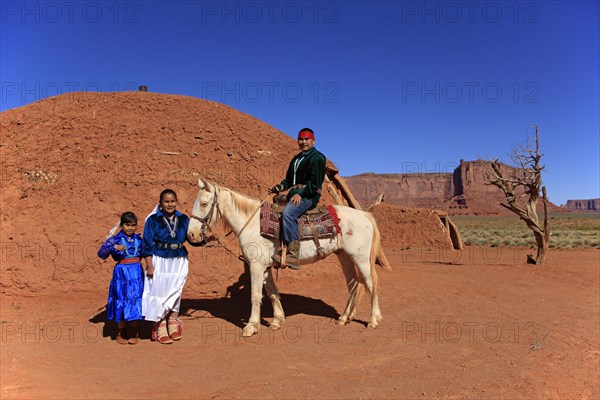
xmin=483 ymin=125 xmax=550 ymax=264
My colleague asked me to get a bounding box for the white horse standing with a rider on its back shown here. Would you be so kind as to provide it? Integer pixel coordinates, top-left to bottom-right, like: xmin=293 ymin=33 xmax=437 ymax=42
xmin=187 ymin=179 xmax=383 ymax=337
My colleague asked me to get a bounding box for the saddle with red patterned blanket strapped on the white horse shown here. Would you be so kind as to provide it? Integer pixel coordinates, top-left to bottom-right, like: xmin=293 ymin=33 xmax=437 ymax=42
xmin=260 ymin=195 xmax=340 ymax=253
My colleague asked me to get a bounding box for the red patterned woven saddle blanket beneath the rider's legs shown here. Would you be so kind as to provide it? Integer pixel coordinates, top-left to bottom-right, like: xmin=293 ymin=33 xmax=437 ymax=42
xmin=260 ymin=202 xmax=340 ymax=240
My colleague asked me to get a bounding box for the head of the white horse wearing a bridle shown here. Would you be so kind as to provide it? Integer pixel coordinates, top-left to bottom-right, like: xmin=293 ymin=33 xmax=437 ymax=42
xmin=187 ymin=179 xmax=219 ymax=243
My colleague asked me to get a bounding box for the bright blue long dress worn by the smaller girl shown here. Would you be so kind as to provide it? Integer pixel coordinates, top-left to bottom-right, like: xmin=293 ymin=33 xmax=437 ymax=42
xmin=98 ymin=231 xmax=144 ymax=322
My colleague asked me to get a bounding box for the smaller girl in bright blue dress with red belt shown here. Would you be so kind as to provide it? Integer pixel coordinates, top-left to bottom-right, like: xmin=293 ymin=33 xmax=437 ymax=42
xmin=98 ymin=211 xmax=144 ymax=344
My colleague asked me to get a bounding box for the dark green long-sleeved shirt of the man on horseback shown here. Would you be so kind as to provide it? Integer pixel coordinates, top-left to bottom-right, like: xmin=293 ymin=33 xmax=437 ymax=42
xmin=281 ymin=147 xmax=326 ymax=207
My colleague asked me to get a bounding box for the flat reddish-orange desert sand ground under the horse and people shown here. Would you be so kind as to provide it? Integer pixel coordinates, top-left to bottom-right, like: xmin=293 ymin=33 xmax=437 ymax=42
xmin=0 ymin=247 xmax=600 ymax=399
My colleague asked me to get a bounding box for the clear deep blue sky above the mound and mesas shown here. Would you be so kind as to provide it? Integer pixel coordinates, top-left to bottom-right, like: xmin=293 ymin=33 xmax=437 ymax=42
xmin=0 ymin=0 xmax=600 ymax=204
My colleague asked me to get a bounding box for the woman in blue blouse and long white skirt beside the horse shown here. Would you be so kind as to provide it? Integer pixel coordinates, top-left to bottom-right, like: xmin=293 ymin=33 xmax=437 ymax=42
xmin=142 ymin=189 xmax=190 ymax=344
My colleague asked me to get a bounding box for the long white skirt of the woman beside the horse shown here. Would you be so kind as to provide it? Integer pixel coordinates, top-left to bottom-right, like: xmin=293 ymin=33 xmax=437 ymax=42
xmin=142 ymin=255 xmax=188 ymax=322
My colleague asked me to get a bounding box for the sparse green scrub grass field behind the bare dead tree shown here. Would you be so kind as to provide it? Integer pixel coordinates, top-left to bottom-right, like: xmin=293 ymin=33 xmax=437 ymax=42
xmin=451 ymin=213 xmax=600 ymax=249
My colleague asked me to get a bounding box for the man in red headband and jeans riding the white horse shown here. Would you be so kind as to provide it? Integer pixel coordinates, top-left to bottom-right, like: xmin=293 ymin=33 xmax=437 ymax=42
xmin=269 ymin=128 xmax=326 ymax=270
